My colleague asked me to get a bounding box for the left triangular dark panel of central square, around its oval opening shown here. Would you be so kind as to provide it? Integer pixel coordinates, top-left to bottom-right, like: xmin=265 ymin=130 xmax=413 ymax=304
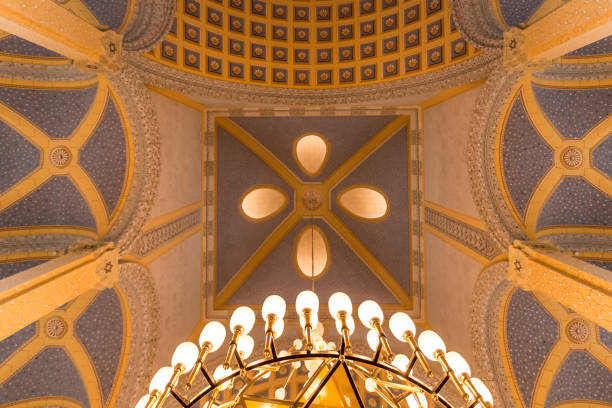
xmin=216 ymin=127 xmax=293 ymax=291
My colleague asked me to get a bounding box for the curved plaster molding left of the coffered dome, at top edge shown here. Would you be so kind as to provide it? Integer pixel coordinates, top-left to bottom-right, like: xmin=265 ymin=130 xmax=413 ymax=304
xmin=123 ymin=0 xmax=176 ymax=52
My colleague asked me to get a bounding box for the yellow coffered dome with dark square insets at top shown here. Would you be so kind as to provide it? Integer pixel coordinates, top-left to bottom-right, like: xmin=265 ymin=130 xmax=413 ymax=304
xmin=146 ymin=0 xmax=477 ymax=88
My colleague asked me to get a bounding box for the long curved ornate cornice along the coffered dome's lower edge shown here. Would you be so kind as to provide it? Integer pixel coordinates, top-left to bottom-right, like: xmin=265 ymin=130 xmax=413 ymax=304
xmin=126 ymin=53 xmax=499 ymax=106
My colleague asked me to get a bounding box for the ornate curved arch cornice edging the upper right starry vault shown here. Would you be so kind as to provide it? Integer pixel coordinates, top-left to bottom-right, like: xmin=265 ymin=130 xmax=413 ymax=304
xmin=468 ymin=61 xmax=525 ymax=248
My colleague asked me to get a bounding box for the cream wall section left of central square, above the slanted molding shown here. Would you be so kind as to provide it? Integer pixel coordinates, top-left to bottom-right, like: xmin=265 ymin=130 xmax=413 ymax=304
xmin=148 ymin=91 xmax=202 ymax=218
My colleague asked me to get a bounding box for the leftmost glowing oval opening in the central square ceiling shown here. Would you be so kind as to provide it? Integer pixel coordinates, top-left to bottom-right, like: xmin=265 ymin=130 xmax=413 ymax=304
xmin=239 ymin=185 xmax=288 ymax=222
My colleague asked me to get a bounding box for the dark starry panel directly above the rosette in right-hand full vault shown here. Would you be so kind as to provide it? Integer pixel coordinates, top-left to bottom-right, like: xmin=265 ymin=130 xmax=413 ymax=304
xmin=532 ymin=85 xmax=612 ymax=139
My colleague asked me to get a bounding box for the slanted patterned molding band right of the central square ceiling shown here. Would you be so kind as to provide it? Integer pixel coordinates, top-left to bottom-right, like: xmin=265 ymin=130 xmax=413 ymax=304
xmin=425 ymin=207 xmax=504 ymax=259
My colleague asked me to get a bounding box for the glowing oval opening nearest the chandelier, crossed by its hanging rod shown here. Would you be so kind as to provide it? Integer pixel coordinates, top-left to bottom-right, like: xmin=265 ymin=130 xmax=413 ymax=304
xmin=293 ymin=225 xmax=330 ymax=279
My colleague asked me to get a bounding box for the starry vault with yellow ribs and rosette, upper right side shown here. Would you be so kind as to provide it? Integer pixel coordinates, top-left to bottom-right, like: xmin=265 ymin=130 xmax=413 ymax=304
xmin=495 ymin=76 xmax=612 ymax=238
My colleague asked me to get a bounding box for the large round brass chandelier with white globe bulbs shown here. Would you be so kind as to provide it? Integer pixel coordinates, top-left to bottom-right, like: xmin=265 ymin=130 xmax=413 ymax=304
xmin=135 ymin=290 xmax=493 ymax=408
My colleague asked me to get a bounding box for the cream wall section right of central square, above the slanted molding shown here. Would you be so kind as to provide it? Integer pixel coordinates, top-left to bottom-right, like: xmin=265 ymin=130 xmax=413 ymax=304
xmin=423 ymin=86 xmax=482 ymax=218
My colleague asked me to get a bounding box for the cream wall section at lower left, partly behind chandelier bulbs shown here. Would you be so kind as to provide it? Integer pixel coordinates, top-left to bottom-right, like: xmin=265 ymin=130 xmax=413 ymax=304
xmin=149 ymin=233 xmax=201 ymax=367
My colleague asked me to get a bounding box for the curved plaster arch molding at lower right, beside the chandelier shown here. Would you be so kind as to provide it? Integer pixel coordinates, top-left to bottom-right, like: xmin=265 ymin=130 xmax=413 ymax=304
xmin=472 ymin=262 xmax=516 ymax=408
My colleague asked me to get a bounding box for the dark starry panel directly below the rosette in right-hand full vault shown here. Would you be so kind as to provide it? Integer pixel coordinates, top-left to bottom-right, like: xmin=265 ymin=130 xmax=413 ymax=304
xmin=537 ymin=177 xmax=612 ymax=229
